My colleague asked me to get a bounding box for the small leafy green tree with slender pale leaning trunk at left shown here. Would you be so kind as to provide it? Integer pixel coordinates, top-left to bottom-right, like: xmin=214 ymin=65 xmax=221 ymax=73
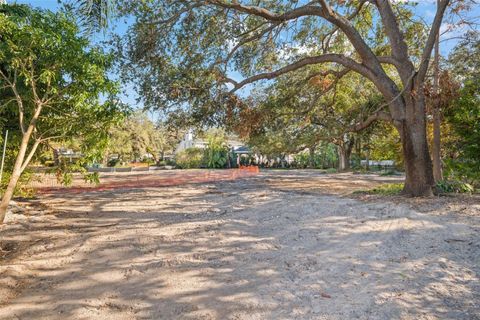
xmin=0 ymin=5 xmax=121 ymax=223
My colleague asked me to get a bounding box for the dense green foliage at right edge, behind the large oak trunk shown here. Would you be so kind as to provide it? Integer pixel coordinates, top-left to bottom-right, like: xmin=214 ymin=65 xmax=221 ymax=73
xmin=443 ymin=32 xmax=480 ymax=186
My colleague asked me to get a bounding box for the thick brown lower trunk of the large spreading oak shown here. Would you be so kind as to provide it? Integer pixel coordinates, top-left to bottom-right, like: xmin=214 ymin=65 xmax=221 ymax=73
xmin=399 ymin=95 xmax=434 ymax=197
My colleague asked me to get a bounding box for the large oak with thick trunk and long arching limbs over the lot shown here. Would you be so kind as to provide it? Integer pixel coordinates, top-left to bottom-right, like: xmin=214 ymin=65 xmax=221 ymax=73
xmin=109 ymin=0 xmax=464 ymax=196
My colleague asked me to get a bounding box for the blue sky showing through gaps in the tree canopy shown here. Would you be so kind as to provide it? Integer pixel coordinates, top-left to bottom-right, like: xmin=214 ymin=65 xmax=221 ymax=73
xmin=7 ymin=0 xmax=480 ymax=112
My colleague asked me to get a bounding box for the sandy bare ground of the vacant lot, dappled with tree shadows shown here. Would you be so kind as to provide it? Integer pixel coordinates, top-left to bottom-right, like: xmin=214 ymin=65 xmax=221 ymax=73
xmin=0 ymin=171 xmax=480 ymax=320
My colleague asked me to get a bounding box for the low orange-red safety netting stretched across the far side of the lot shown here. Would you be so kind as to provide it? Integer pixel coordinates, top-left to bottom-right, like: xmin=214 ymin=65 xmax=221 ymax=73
xmin=35 ymin=166 xmax=260 ymax=194
